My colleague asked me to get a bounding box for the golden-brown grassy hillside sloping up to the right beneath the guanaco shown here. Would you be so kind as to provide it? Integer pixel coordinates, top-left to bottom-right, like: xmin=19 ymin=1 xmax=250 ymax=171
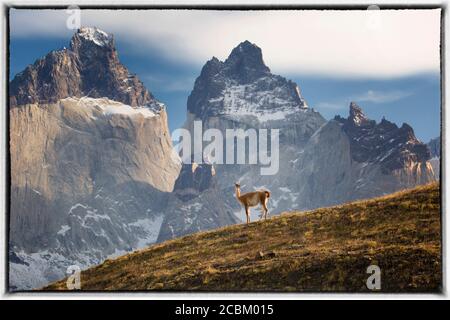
xmin=45 ymin=184 xmax=442 ymax=292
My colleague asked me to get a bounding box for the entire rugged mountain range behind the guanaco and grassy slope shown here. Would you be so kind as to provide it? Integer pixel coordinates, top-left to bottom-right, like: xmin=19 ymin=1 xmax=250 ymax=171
xmin=9 ymin=27 xmax=439 ymax=290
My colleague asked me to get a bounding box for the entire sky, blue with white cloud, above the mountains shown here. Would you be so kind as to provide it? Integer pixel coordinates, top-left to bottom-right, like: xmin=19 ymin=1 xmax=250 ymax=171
xmin=10 ymin=10 xmax=440 ymax=141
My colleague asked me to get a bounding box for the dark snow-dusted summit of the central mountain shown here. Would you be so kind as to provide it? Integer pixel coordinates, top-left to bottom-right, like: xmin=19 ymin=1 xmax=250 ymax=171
xmin=188 ymin=41 xmax=308 ymax=122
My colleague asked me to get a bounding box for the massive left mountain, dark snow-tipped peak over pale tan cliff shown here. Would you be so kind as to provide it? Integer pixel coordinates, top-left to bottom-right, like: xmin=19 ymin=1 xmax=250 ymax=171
xmin=10 ymin=28 xmax=180 ymax=289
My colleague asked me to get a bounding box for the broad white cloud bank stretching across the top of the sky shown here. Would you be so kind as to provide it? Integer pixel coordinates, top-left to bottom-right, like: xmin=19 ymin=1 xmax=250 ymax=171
xmin=10 ymin=9 xmax=440 ymax=77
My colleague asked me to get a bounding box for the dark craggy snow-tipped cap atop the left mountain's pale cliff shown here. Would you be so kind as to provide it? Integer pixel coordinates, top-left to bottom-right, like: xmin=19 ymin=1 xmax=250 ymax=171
xmin=10 ymin=27 xmax=156 ymax=111
